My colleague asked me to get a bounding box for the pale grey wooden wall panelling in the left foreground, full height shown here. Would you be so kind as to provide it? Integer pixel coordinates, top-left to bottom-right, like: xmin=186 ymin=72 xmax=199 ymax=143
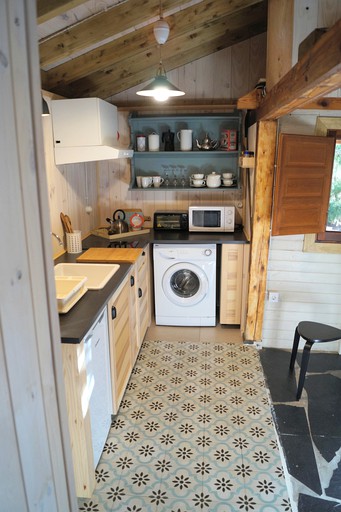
xmin=0 ymin=0 xmax=76 ymax=511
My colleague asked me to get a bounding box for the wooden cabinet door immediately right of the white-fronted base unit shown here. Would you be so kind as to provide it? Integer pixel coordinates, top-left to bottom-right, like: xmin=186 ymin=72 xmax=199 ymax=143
xmin=108 ymin=278 xmax=132 ymax=414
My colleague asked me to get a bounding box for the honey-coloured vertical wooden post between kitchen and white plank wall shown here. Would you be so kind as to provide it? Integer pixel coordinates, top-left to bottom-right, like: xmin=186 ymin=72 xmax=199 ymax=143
xmin=244 ymin=121 xmax=277 ymax=341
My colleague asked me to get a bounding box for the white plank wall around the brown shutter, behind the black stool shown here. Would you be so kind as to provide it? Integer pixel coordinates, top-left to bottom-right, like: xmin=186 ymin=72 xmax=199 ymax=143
xmin=262 ymin=110 xmax=341 ymax=351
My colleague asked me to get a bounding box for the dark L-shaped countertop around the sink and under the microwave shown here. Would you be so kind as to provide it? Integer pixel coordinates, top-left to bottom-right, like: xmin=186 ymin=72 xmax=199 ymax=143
xmin=54 ymin=229 xmax=249 ymax=343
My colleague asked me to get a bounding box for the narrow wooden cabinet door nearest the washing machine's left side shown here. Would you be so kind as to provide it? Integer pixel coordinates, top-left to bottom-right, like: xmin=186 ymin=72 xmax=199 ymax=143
xmin=137 ymin=248 xmax=151 ymax=344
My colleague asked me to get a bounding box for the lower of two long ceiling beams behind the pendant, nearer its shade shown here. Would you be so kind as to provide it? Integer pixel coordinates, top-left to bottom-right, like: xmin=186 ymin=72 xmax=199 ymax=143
xmin=44 ymin=2 xmax=266 ymax=98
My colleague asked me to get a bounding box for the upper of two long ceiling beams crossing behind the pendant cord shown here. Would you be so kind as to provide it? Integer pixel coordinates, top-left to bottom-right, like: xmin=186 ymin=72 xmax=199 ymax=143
xmin=39 ymin=0 xmax=264 ymax=69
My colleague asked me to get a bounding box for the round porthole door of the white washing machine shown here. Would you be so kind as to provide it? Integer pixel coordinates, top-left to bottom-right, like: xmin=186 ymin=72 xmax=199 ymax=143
xmin=162 ymin=262 xmax=208 ymax=306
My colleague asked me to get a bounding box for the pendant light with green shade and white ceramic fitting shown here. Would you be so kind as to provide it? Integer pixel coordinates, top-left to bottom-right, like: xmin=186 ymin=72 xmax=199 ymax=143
xmin=136 ymin=0 xmax=185 ymax=101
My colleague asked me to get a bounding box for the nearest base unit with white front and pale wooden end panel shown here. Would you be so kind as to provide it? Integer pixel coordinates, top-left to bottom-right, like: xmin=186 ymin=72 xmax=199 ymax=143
xmin=62 ymin=309 xmax=112 ymax=497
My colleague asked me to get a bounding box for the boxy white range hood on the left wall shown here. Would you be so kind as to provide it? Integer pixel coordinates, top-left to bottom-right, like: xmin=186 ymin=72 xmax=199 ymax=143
xmin=51 ymin=98 xmax=133 ymax=165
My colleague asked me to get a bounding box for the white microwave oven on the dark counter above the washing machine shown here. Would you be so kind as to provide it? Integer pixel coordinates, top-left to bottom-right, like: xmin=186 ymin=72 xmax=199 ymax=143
xmin=188 ymin=206 xmax=235 ymax=233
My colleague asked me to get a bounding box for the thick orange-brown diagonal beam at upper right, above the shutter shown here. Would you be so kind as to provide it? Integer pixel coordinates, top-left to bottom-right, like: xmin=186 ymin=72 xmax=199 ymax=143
xmin=257 ymin=19 xmax=341 ymax=120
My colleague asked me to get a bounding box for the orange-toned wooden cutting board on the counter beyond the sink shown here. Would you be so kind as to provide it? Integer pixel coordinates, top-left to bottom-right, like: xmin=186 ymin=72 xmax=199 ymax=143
xmin=76 ymin=247 xmax=143 ymax=263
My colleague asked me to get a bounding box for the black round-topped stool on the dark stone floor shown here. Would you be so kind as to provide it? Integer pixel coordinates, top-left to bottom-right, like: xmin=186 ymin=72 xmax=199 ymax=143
xmin=290 ymin=322 xmax=341 ymax=400
